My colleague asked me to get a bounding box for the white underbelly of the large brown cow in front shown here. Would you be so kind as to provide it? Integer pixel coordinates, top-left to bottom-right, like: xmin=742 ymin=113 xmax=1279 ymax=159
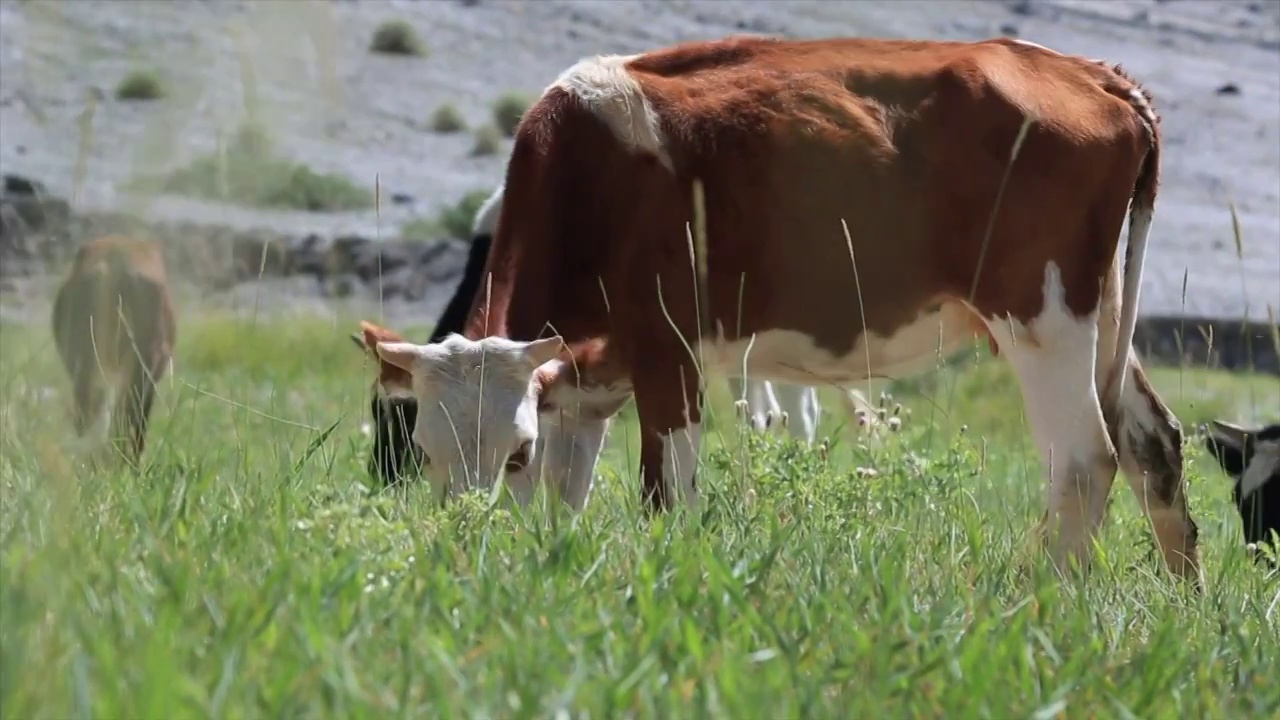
xmin=703 ymin=305 xmax=975 ymax=386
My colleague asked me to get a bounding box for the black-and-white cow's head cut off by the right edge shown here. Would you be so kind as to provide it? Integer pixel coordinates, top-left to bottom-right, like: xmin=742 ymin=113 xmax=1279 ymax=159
xmin=1204 ymin=420 xmax=1280 ymax=557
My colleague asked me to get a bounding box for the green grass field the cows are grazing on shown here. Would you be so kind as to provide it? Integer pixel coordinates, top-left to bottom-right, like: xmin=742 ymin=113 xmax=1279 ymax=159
xmin=0 ymin=311 xmax=1280 ymax=719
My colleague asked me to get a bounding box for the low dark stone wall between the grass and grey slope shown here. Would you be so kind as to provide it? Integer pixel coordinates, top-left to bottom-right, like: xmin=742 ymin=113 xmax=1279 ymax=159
xmin=0 ymin=176 xmax=1280 ymax=375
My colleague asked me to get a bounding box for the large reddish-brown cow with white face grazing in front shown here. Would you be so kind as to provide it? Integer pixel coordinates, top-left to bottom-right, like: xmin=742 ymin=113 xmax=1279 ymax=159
xmin=376 ymin=37 xmax=1201 ymax=588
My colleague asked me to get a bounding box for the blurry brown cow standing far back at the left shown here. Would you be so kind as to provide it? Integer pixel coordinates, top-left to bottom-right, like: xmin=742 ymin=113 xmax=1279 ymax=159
xmin=52 ymin=236 xmax=177 ymax=465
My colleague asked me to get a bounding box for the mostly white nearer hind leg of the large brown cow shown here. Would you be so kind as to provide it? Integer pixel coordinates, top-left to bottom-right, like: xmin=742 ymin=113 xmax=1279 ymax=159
xmin=988 ymin=263 xmax=1116 ymax=568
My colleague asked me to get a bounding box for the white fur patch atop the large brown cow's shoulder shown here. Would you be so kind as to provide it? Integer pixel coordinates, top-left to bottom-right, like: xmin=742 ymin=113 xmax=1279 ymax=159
xmin=548 ymin=55 xmax=675 ymax=172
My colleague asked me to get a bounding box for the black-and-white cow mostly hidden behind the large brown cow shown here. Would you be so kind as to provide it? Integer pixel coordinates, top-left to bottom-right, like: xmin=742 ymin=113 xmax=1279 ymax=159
xmin=351 ymin=186 xmax=877 ymax=484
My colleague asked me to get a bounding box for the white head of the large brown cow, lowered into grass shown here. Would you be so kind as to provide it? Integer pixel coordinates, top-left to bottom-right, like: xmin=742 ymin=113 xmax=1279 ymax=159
xmin=376 ymin=334 xmax=563 ymax=495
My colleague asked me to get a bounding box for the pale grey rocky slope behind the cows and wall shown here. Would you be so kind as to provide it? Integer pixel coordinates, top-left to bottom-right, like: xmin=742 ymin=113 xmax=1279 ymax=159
xmin=0 ymin=0 xmax=1280 ymax=363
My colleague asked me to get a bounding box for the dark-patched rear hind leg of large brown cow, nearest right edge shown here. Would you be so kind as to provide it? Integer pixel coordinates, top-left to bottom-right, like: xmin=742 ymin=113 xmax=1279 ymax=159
xmin=1116 ymin=354 xmax=1201 ymax=584
